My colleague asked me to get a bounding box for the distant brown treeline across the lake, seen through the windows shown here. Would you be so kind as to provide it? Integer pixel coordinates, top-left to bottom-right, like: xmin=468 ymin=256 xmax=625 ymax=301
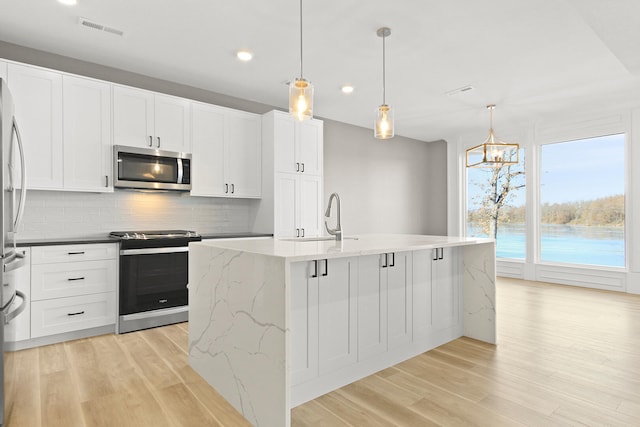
xmin=469 ymin=195 xmax=624 ymax=226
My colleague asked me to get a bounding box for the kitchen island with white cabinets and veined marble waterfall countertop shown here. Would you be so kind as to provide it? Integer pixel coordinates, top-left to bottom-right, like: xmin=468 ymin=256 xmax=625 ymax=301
xmin=189 ymin=235 xmax=496 ymax=427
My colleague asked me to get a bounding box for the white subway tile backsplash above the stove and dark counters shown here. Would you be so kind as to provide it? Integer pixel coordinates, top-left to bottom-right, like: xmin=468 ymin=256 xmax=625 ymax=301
xmin=18 ymin=190 xmax=259 ymax=240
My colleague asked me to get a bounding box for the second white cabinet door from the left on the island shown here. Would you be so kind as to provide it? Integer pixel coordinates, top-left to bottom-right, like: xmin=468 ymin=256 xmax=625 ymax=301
xmin=318 ymin=257 xmax=358 ymax=375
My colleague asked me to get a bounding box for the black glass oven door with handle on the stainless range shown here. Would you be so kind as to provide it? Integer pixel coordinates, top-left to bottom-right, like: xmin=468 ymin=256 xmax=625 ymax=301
xmin=120 ymin=246 xmax=189 ymax=315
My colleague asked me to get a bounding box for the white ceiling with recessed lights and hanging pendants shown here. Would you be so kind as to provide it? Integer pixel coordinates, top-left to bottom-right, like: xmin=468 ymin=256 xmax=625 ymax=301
xmin=0 ymin=0 xmax=640 ymax=141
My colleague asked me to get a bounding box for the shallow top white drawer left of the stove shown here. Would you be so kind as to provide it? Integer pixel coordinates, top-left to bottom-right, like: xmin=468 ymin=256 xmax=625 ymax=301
xmin=31 ymin=243 xmax=118 ymax=264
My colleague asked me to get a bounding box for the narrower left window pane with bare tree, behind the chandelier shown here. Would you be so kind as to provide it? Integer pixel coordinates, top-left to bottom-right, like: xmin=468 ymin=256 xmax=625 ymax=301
xmin=467 ymin=149 xmax=526 ymax=259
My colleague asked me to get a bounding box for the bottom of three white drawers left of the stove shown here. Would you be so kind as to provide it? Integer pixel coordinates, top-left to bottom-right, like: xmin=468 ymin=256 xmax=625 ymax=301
xmin=31 ymin=292 xmax=116 ymax=338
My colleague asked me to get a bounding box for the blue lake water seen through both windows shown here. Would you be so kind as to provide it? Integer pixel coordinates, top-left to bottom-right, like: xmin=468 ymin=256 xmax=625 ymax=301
xmin=467 ymin=224 xmax=625 ymax=267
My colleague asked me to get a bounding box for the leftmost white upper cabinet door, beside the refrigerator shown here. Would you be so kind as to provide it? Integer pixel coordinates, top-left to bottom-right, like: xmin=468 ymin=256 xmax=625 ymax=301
xmin=7 ymin=63 xmax=63 ymax=190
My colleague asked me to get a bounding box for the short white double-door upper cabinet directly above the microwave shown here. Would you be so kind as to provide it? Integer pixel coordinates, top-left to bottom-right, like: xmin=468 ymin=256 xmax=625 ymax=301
xmin=113 ymin=85 xmax=191 ymax=153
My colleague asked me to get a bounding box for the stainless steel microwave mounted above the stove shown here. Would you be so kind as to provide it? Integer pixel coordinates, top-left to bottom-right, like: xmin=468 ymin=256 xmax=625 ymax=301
xmin=113 ymin=145 xmax=191 ymax=191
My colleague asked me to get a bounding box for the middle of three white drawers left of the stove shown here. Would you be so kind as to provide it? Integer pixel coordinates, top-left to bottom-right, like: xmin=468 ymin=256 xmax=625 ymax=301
xmin=31 ymin=260 xmax=117 ymax=301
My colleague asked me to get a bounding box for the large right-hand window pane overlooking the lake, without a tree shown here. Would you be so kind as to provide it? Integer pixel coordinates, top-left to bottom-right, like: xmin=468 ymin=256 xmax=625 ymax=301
xmin=539 ymin=134 xmax=625 ymax=267
